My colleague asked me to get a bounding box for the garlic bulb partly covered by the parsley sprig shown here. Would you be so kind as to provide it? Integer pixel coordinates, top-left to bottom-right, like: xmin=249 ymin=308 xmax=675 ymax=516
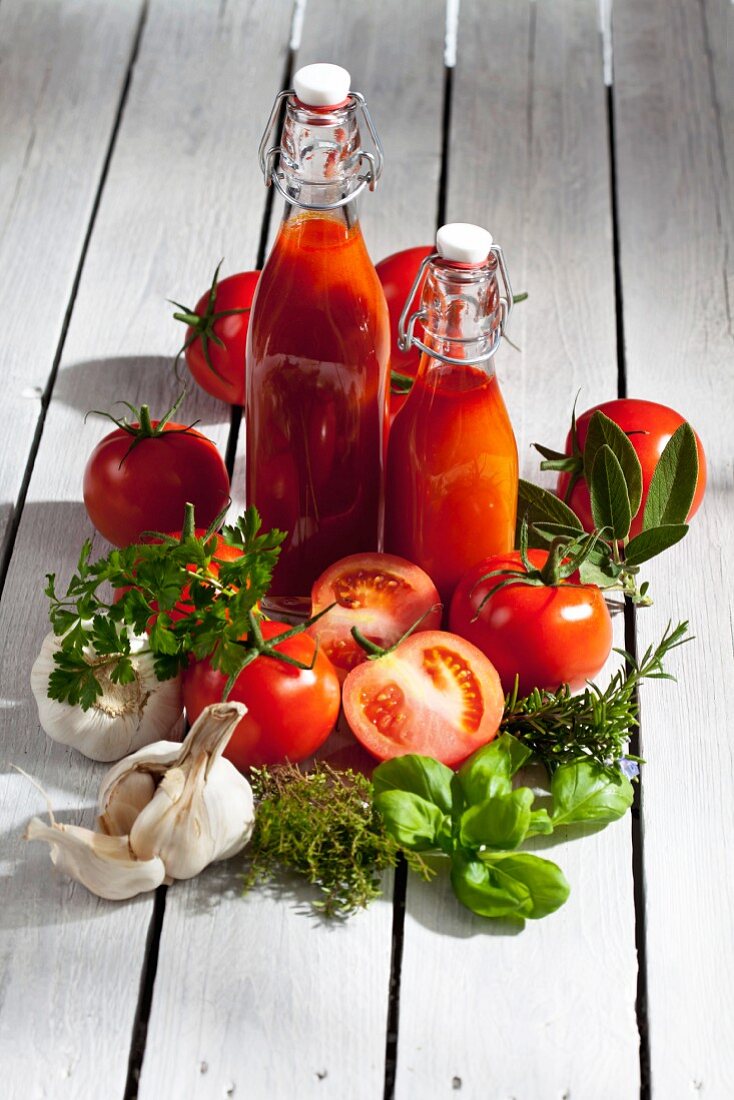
xmin=31 ymin=634 xmax=184 ymax=761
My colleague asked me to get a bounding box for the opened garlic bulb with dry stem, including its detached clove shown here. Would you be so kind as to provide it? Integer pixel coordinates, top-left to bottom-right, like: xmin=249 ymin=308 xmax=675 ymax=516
xmin=25 ymin=703 xmax=254 ymax=899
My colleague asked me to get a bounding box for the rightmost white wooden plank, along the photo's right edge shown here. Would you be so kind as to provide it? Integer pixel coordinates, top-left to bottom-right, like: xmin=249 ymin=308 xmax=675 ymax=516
xmin=614 ymin=0 xmax=734 ymax=1100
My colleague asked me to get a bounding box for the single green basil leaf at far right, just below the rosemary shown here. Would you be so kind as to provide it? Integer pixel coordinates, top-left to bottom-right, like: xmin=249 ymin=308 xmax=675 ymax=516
xmin=550 ymin=760 xmax=633 ymax=826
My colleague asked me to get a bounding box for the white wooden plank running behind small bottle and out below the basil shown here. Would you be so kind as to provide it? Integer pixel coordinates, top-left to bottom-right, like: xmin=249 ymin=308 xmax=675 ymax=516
xmin=396 ymin=0 xmax=638 ymax=1100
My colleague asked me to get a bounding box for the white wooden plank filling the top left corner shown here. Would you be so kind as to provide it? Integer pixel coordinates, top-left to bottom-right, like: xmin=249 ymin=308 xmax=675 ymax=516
xmin=0 ymin=0 xmax=142 ymax=556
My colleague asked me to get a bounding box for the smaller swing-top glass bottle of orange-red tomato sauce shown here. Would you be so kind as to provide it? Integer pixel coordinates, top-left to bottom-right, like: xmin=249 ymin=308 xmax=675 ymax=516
xmin=385 ymin=223 xmax=518 ymax=606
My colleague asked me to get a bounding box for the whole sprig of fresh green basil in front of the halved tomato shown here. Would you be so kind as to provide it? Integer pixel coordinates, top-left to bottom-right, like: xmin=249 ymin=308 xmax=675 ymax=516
xmin=373 ymin=734 xmax=632 ymax=920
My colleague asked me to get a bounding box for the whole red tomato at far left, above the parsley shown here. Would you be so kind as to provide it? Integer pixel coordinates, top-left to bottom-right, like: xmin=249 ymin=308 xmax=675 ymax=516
xmin=84 ymin=405 xmax=229 ymax=547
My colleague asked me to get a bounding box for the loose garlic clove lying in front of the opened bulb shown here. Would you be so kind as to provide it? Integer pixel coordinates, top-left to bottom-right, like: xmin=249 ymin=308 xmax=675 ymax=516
xmin=25 ymin=817 xmax=166 ymax=901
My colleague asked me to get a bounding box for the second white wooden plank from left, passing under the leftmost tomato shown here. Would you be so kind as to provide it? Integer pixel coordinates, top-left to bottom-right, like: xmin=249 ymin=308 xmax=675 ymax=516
xmin=0 ymin=0 xmax=289 ymax=1100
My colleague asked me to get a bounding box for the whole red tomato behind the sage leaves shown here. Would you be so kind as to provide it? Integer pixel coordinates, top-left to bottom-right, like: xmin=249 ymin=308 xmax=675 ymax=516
xmin=557 ymin=397 xmax=706 ymax=538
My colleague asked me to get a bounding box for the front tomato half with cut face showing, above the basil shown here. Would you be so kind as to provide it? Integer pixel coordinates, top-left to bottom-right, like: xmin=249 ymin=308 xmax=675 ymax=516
xmin=342 ymin=630 xmax=504 ymax=766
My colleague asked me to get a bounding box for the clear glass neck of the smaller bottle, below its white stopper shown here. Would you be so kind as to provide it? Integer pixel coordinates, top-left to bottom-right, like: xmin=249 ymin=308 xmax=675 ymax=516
xmin=421 ymin=255 xmax=502 ymax=374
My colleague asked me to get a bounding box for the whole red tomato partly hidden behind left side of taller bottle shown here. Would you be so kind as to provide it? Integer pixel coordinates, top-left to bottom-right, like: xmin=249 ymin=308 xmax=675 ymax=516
xmin=174 ymin=267 xmax=260 ymax=405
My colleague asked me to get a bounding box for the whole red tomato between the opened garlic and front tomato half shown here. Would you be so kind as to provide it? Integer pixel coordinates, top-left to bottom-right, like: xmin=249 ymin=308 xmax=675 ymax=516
xmin=184 ymin=623 xmax=340 ymax=771
